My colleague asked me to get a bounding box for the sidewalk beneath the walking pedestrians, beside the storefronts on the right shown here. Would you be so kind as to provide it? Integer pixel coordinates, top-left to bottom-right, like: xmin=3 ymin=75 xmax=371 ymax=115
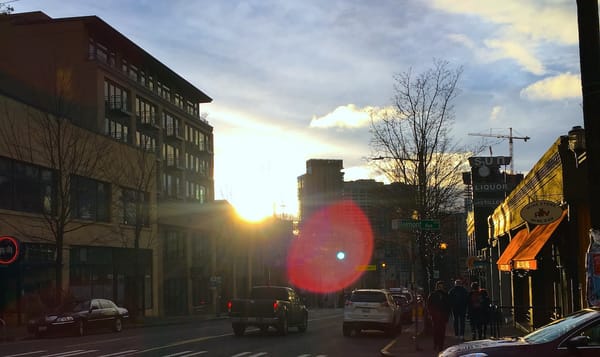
xmin=380 ymin=320 xmax=524 ymax=357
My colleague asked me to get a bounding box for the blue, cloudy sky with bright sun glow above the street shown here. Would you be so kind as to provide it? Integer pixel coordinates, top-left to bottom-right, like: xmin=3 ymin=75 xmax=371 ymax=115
xmin=7 ymin=0 xmax=583 ymax=219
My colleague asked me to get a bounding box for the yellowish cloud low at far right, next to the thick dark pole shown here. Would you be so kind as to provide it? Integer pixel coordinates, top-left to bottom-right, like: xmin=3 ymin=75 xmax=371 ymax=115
xmin=521 ymin=72 xmax=581 ymax=100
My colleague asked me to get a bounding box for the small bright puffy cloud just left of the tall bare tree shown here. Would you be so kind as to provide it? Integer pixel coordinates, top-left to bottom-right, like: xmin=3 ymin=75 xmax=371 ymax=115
xmin=310 ymin=104 xmax=378 ymax=128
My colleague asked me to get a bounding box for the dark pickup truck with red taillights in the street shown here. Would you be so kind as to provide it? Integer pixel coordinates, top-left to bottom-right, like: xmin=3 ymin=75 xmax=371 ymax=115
xmin=227 ymin=286 xmax=308 ymax=336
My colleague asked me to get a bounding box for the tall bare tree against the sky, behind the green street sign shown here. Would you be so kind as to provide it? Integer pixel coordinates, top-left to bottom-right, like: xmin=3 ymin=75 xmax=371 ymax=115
xmin=371 ymin=60 xmax=469 ymax=292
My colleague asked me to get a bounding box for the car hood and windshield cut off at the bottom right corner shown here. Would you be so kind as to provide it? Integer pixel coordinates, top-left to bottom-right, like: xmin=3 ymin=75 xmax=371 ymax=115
xmin=439 ymin=308 xmax=600 ymax=357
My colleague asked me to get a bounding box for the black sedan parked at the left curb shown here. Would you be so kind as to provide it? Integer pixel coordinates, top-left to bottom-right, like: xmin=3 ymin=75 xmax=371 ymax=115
xmin=27 ymin=299 xmax=129 ymax=337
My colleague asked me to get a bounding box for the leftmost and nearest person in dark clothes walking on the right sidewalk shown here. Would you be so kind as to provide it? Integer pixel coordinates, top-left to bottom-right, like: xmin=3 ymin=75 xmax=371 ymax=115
xmin=427 ymin=281 xmax=451 ymax=352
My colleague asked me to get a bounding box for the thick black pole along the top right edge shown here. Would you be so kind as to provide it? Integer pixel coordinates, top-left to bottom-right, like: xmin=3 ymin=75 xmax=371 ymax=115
xmin=577 ymin=0 xmax=600 ymax=229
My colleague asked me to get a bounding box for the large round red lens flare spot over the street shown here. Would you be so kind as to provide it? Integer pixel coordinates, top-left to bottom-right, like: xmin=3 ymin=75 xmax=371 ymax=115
xmin=287 ymin=201 xmax=373 ymax=293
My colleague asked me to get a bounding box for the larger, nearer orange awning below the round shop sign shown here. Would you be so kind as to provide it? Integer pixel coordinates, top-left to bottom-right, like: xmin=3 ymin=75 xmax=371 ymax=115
xmin=512 ymin=210 xmax=567 ymax=270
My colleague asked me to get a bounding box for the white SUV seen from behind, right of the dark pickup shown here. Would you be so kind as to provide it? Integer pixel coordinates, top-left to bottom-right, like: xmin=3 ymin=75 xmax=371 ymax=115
xmin=342 ymin=289 xmax=401 ymax=336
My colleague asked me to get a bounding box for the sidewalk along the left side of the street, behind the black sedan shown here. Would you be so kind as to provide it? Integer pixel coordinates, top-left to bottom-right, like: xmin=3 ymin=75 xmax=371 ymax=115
xmin=0 ymin=313 xmax=228 ymax=343
